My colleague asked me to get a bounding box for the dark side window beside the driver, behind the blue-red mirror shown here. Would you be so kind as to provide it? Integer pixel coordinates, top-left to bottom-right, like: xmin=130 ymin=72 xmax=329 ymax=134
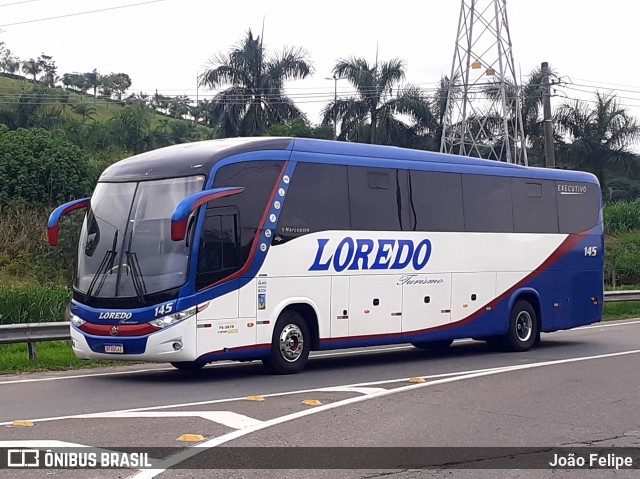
xmin=196 ymin=206 xmax=242 ymax=288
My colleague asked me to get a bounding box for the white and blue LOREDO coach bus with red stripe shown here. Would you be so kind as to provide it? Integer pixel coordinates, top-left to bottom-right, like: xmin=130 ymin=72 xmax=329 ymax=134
xmin=48 ymin=138 xmax=604 ymax=373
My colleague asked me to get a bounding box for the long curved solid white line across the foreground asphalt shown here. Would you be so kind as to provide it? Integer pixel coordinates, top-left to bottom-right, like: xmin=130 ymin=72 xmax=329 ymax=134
xmin=131 ymin=349 xmax=640 ymax=479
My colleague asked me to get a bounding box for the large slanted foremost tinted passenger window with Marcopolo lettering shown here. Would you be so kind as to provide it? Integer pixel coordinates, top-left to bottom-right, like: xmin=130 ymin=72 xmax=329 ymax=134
xmin=273 ymin=163 xmax=350 ymax=244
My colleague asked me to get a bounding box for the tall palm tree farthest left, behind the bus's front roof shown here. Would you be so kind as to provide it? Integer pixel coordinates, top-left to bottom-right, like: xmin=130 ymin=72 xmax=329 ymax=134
xmin=200 ymin=30 xmax=313 ymax=137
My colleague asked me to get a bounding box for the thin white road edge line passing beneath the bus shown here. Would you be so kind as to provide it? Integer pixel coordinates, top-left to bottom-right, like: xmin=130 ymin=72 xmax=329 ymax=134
xmin=0 ymin=320 xmax=640 ymax=386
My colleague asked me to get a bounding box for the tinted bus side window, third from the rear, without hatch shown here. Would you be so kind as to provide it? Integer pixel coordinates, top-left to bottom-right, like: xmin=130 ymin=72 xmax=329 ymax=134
xmin=462 ymin=175 xmax=513 ymax=233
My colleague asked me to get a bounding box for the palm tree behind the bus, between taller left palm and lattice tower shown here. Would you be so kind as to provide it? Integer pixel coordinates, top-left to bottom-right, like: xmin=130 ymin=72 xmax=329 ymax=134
xmin=322 ymin=57 xmax=433 ymax=146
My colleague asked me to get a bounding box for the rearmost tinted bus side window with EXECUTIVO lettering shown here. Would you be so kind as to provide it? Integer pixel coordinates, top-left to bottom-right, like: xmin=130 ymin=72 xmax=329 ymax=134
xmin=556 ymin=181 xmax=600 ymax=233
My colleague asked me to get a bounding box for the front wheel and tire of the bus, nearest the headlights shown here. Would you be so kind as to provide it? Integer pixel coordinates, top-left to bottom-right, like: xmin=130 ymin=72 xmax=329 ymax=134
xmin=262 ymin=310 xmax=311 ymax=374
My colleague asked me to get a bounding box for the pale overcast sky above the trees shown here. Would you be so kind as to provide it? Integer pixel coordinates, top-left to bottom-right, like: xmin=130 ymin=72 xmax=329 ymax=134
xmin=0 ymin=0 xmax=640 ymax=122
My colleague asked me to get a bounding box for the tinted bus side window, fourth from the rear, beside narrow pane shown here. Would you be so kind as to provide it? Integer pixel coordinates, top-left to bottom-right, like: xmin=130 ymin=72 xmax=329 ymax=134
xmin=409 ymin=171 xmax=464 ymax=231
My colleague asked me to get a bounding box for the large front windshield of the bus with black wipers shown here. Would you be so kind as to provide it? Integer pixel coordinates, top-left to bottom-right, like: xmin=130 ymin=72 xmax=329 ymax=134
xmin=75 ymin=176 xmax=204 ymax=300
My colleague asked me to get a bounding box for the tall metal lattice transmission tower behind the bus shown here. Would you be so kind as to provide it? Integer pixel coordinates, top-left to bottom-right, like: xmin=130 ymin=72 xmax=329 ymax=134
xmin=440 ymin=0 xmax=527 ymax=165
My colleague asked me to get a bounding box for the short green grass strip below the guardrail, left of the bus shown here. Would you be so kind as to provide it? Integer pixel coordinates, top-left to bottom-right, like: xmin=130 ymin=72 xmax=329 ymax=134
xmin=0 ymin=341 xmax=131 ymax=374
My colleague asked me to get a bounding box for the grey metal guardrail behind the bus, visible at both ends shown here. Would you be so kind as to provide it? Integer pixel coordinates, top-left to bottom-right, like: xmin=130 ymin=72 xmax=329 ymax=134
xmin=0 ymin=290 xmax=640 ymax=359
